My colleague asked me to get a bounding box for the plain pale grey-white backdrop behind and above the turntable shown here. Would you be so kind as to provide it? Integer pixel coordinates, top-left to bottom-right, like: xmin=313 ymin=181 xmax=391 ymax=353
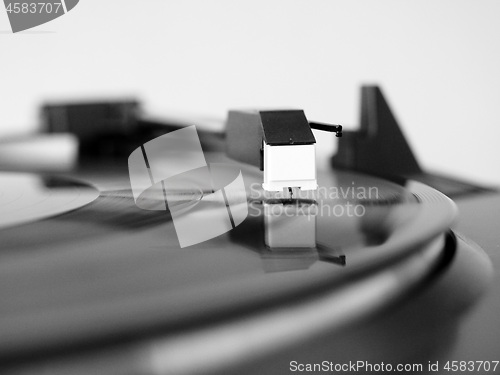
xmin=0 ymin=0 xmax=500 ymax=185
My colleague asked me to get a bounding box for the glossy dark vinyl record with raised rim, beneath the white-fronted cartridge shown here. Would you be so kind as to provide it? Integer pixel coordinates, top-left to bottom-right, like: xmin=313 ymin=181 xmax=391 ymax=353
xmin=0 ymin=166 xmax=455 ymax=353
